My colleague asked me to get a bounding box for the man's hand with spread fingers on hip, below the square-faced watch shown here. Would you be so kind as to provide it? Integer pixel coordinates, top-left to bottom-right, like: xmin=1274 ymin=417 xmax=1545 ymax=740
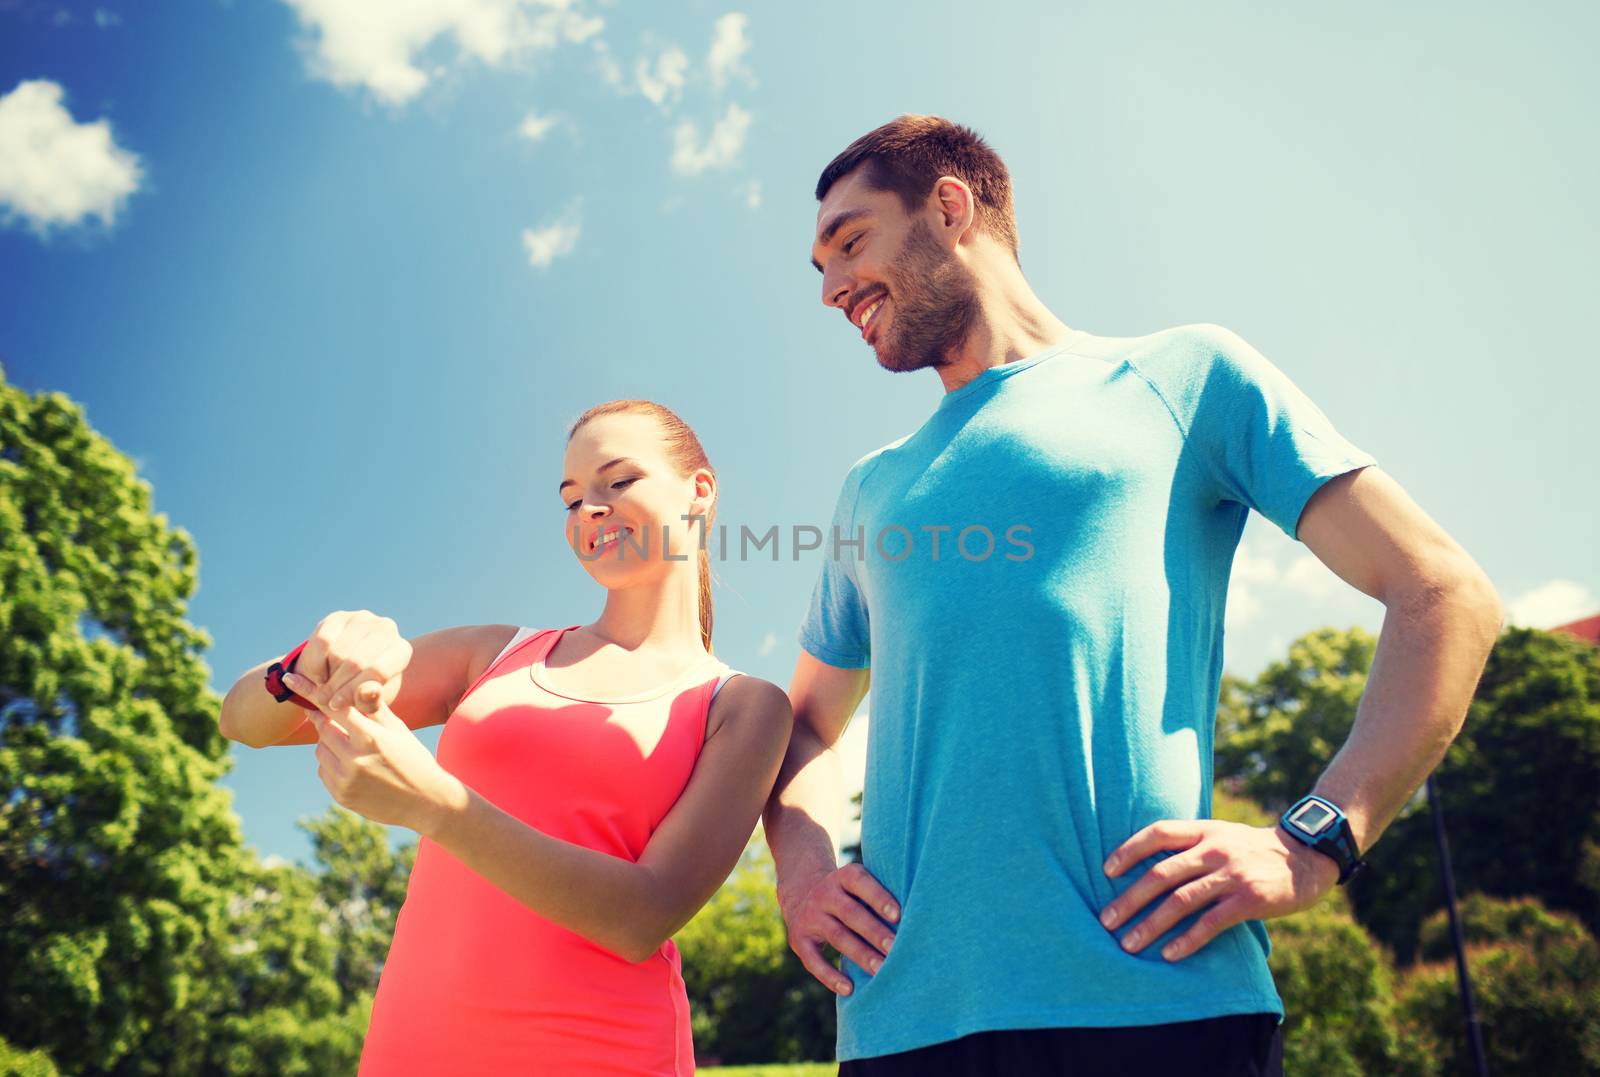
xmin=1101 ymin=819 xmax=1339 ymax=962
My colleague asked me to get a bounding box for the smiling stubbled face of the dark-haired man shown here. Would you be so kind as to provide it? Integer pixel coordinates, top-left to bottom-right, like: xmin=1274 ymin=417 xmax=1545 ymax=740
xmin=811 ymin=163 xmax=978 ymax=371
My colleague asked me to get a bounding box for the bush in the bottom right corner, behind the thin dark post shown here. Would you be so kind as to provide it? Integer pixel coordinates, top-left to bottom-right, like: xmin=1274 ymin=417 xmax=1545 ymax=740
xmin=1400 ymin=895 xmax=1600 ymax=1074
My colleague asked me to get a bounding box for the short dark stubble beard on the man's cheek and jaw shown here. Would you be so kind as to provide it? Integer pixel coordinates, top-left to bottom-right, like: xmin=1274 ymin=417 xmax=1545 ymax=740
xmin=877 ymin=221 xmax=979 ymax=373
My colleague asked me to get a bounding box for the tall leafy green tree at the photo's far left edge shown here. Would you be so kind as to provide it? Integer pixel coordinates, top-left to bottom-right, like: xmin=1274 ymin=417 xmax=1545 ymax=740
xmin=0 ymin=369 xmax=242 ymax=1074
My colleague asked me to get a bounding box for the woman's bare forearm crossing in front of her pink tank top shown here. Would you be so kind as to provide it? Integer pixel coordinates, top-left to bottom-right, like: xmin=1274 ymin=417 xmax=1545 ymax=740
xmin=418 ymin=779 xmax=677 ymax=962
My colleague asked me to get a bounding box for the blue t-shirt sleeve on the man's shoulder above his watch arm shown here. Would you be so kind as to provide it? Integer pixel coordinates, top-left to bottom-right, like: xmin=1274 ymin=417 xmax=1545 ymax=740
xmin=1139 ymin=326 xmax=1378 ymax=538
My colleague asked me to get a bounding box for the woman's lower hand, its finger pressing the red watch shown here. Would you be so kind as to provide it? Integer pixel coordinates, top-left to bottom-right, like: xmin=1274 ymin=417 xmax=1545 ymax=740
xmin=283 ymin=674 xmax=467 ymax=834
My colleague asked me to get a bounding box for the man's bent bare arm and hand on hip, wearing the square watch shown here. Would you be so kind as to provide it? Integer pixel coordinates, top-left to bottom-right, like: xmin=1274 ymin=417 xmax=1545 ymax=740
xmin=1101 ymin=467 xmax=1502 ymax=960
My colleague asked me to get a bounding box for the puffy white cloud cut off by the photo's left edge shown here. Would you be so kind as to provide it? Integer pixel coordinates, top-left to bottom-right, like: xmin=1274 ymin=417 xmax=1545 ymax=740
xmin=0 ymin=78 xmax=142 ymax=234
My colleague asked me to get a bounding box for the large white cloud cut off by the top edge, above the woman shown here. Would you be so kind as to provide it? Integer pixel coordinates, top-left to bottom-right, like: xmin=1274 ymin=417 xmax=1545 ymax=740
xmin=283 ymin=0 xmax=603 ymax=106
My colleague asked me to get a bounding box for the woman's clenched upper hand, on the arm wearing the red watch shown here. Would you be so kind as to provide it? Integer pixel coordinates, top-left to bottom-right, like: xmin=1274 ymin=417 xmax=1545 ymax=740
xmin=296 ymin=610 xmax=411 ymax=715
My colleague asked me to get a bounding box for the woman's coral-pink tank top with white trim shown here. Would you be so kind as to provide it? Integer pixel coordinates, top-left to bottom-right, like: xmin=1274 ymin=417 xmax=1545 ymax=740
xmin=360 ymin=629 xmax=730 ymax=1077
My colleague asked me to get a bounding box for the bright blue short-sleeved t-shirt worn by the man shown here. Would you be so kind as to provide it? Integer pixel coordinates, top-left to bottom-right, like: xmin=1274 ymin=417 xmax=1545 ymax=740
xmin=800 ymin=326 xmax=1374 ymax=1061
